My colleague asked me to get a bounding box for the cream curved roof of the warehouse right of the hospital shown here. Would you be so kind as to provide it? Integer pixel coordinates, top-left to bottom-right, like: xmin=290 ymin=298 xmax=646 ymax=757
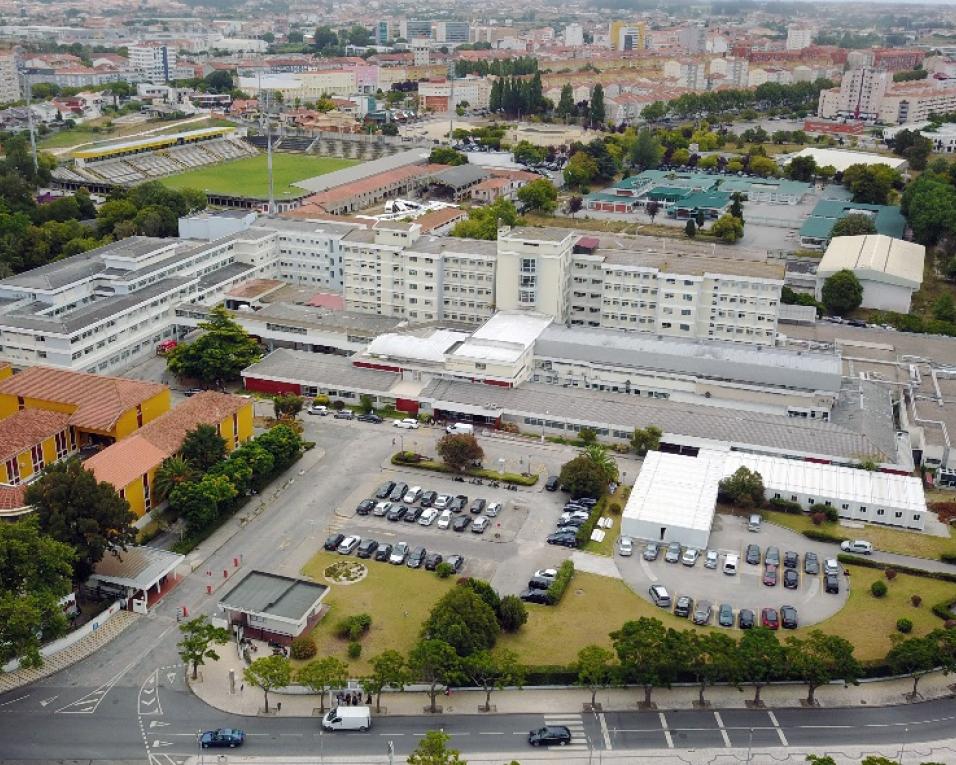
xmin=817 ymin=234 xmax=926 ymax=289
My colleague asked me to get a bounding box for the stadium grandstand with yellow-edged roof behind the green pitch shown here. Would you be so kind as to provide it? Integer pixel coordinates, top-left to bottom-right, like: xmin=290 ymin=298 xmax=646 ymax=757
xmin=53 ymin=128 xmax=258 ymax=189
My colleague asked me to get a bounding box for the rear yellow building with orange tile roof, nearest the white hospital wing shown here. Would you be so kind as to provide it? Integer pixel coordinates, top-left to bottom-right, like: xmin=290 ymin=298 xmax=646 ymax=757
xmin=0 ymin=367 xmax=169 ymax=447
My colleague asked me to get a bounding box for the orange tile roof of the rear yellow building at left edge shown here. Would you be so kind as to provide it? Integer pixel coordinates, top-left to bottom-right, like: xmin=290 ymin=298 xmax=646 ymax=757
xmin=0 ymin=367 xmax=166 ymax=431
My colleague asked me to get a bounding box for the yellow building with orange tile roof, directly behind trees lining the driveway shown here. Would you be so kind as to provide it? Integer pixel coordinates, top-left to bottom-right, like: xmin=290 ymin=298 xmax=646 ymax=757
xmin=84 ymin=391 xmax=252 ymax=517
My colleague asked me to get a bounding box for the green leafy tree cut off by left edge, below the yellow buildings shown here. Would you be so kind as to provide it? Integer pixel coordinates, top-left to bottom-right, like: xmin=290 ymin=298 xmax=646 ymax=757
xmin=0 ymin=516 xmax=74 ymax=667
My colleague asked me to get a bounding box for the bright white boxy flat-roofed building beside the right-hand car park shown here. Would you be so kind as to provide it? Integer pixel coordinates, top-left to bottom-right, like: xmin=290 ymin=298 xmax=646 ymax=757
xmin=621 ymin=451 xmax=725 ymax=549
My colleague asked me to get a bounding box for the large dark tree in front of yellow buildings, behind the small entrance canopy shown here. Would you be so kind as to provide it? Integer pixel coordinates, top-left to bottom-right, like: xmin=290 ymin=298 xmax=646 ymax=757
xmin=26 ymin=458 xmax=136 ymax=582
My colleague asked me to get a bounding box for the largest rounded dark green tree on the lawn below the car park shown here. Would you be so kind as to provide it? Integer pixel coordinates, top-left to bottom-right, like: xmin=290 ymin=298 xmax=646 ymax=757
xmin=422 ymin=587 xmax=501 ymax=656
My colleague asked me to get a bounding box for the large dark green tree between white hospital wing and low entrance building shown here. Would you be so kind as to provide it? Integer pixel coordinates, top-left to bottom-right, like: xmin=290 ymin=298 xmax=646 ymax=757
xmin=166 ymin=306 xmax=260 ymax=383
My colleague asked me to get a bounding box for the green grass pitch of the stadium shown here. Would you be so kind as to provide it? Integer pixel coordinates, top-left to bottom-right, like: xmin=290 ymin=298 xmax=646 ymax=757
xmin=161 ymin=153 xmax=358 ymax=199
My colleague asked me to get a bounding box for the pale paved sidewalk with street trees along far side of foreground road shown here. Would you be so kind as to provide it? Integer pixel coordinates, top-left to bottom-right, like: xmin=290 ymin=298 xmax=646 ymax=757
xmin=190 ymin=646 xmax=956 ymax=716
